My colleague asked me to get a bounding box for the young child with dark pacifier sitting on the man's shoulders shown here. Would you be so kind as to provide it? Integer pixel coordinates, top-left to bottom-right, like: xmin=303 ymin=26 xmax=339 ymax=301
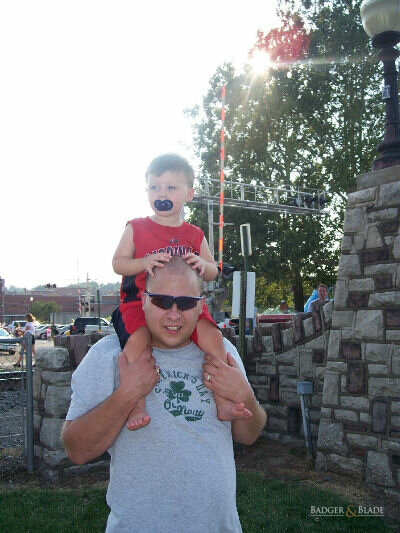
xmin=112 ymin=154 xmax=251 ymax=430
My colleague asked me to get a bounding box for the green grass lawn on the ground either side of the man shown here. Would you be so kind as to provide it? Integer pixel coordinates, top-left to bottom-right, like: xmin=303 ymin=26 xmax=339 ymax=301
xmin=0 ymin=473 xmax=399 ymax=533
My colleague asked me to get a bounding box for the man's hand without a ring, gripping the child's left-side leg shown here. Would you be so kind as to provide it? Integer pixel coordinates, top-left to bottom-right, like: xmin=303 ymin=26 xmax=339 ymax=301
xmin=118 ymin=346 xmax=159 ymax=399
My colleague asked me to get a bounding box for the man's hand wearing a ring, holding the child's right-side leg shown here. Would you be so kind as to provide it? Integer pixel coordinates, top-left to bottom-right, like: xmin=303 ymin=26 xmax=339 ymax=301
xmin=203 ymin=352 xmax=253 ymax=404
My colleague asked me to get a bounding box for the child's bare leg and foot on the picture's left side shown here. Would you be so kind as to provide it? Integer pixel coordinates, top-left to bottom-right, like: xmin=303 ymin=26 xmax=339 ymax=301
xmin=123 ymin=326 xmax=151 ymax=431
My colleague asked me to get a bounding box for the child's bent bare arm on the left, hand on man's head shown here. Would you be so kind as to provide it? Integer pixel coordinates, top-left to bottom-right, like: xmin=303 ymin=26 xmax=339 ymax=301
xmin=112 ymin=224 xmax=171 ymax=276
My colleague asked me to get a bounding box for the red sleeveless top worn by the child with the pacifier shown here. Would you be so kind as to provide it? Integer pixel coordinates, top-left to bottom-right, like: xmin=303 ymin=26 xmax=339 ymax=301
xmin=120 ymin=217 xmax=204 ymax=304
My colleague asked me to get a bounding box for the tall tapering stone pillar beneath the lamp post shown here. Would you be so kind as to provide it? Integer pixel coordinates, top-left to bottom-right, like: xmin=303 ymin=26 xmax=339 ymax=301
xmin=317 ymin=166 xmax=400 ymax=494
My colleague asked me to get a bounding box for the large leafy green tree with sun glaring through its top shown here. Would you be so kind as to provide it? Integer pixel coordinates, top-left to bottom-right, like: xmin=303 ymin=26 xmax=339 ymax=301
xmin=190 ymin=0 xmax=379 ymax=310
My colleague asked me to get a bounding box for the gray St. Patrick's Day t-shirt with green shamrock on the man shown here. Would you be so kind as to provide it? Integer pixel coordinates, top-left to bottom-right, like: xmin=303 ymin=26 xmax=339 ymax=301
xmin=67 ymin=335 xmax=244 ymax=533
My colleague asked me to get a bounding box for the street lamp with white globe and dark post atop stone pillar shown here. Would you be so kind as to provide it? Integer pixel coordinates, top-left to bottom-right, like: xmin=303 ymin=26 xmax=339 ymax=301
xmin=361 ymin=0 xmax=400 ymax=170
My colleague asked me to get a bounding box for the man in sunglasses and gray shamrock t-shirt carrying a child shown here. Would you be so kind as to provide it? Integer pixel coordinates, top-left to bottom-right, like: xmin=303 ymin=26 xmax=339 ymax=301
xmin=63 ymin=257 xmax=266 ymax=533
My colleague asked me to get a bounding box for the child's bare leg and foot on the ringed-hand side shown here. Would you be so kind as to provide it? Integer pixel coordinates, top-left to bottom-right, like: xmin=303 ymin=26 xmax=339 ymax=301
xmin=197 ymin=319 xmax=252 ymax=420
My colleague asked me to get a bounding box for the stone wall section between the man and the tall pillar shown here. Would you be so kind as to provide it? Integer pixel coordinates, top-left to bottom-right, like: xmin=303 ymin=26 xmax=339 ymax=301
xmin=246 ymin=302 xmax=333 ymax=450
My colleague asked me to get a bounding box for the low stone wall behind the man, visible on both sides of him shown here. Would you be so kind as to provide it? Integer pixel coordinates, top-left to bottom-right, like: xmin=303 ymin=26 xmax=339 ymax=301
xmin=34 ymin=312 xmax=333 ymax=480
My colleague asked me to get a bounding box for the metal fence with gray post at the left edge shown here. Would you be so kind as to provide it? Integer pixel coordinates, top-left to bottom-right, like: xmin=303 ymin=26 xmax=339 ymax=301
xmin=0 ymin=332 xmax=33 ymax=473
